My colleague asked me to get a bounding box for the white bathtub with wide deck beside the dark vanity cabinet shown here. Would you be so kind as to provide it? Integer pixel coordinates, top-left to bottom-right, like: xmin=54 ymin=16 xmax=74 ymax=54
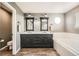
xmin=53 ymin=33 xmax=79 ymax=56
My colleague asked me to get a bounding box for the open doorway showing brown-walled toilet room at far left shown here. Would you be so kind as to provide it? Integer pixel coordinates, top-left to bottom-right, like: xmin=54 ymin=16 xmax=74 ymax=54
xmin=0 ymin=3 xmax=12 ymax=55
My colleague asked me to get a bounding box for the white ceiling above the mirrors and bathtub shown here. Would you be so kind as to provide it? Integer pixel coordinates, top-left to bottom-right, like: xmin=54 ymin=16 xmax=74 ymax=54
xmin=16 ymin=2 xmax=79 ymax=13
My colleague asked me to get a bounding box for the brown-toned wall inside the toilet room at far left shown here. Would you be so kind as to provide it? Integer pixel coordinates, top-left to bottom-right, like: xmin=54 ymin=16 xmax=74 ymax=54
xmin=0 ymin=8 xmax=12 ymax=47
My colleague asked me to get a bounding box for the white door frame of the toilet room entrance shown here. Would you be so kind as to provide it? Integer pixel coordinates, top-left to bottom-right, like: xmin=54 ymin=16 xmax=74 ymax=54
xmin=1 ymin=2 xmax=18 ymax=55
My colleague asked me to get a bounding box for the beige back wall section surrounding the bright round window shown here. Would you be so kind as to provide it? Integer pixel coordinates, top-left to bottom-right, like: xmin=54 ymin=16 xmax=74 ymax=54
xmin=49 ymin=13 xmax=64 ymax=32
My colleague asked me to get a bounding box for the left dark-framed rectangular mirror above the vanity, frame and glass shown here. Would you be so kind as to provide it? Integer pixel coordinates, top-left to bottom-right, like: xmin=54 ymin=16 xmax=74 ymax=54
xmin=25 ymin=17 xmax=34 ymax=31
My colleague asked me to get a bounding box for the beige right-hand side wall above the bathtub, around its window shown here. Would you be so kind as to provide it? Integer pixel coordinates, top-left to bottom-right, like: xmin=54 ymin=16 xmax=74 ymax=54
xmin=65 ymin=6 xmax=79 ymax=33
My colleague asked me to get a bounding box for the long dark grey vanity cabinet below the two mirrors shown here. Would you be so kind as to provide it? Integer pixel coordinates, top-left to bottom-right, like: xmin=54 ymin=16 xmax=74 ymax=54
xmin=20 ymin=34 xmax=53 ymax=48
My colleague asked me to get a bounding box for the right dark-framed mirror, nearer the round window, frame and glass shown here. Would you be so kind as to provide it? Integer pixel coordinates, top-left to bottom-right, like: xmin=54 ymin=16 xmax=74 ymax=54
xmin=40 ymin=17 xmax=48 ymax=31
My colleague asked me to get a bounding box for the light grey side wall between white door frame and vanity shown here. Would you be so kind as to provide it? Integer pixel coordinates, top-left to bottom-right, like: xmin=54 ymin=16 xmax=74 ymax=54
xmin=9 ymin=2 xmax=24 ymax=51
